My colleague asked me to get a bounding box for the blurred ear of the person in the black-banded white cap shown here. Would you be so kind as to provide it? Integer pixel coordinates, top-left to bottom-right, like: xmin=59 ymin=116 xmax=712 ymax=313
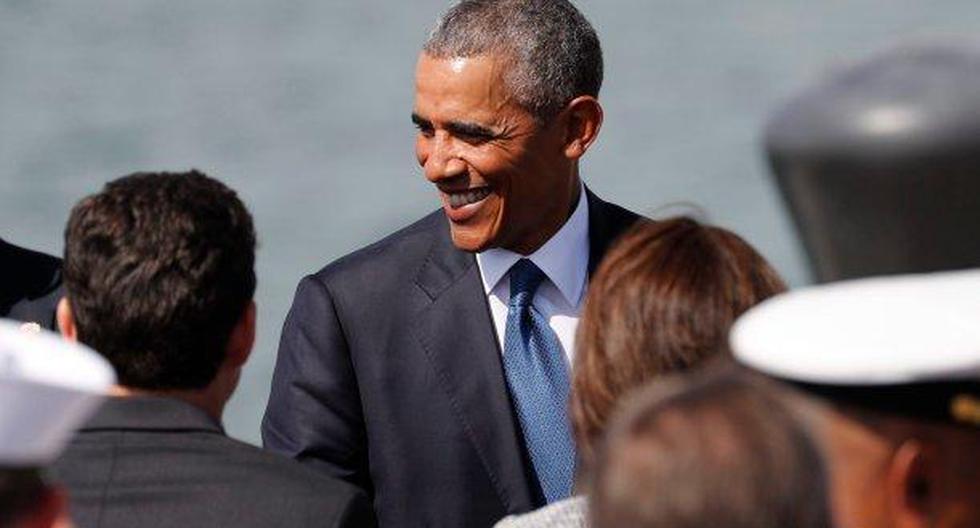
xmin=885 ymin=440 xmax=937 ymax=528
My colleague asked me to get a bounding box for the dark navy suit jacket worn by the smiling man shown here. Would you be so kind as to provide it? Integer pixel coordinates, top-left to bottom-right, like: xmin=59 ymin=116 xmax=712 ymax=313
xmin=262 ymin=193 xmax=637 ymax=528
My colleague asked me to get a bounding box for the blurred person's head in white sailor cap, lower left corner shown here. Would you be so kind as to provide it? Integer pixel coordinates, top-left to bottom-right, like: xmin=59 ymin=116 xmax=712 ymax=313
xmin=0 ymin=321 xmax=115 ymax=528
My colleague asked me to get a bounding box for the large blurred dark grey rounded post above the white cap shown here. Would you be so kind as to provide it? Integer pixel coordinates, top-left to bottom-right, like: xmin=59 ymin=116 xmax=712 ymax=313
xmin=765 ymin=41 xmax=980 ymax=282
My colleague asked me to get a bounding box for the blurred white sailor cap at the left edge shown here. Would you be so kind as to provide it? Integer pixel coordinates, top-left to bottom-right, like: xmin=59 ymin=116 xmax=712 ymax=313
xmin=0 ymin=320 xmax=116 ymax=467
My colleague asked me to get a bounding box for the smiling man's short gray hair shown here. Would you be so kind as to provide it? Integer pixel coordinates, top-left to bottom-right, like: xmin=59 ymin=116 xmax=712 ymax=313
xmin=423 ymin=0 xmax=602 ymax=121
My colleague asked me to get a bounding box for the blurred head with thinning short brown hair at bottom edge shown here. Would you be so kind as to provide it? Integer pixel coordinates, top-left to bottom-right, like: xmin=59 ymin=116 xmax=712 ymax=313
xmin=591 ymin=366 xmax=831 ymax=528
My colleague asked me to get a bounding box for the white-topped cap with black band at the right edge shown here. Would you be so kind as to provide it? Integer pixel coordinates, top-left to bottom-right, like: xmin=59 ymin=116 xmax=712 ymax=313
xmin=729 ymin=269 xmax=980 ymax=425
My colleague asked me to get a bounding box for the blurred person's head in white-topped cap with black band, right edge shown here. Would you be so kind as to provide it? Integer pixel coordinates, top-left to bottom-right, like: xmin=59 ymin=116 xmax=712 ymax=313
xmin=732 ymin=270 xmax=980 ymax=528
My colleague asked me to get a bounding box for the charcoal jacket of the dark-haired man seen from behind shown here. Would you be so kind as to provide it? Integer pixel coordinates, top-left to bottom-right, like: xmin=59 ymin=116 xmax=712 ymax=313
xmin=53 ymin=397 xmax=375 ymax=528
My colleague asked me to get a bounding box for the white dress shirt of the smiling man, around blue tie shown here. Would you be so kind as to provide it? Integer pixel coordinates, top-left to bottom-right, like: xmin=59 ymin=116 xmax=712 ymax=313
xmin=476 ymin=186 xmax=589 ymax=365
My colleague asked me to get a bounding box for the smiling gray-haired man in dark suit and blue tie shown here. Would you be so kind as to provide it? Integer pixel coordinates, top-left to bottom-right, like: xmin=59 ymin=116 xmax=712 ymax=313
xmin=262 ymin=0 xmax=637 ymax=527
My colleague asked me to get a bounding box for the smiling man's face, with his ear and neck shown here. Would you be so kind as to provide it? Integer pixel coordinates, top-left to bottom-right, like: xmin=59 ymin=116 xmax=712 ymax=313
xmin=412 ymin=53 xmax=578 ymax=254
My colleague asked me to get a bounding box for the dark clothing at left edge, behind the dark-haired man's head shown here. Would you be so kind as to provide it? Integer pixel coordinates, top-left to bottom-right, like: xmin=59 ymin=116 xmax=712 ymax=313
xmin=0 ymin=239 xmax=62 ymax=330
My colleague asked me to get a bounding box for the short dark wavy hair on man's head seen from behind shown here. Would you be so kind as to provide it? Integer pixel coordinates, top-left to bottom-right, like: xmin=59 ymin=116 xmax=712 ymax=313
xmin=64 ymin=171 xmax=255 ymax=390
